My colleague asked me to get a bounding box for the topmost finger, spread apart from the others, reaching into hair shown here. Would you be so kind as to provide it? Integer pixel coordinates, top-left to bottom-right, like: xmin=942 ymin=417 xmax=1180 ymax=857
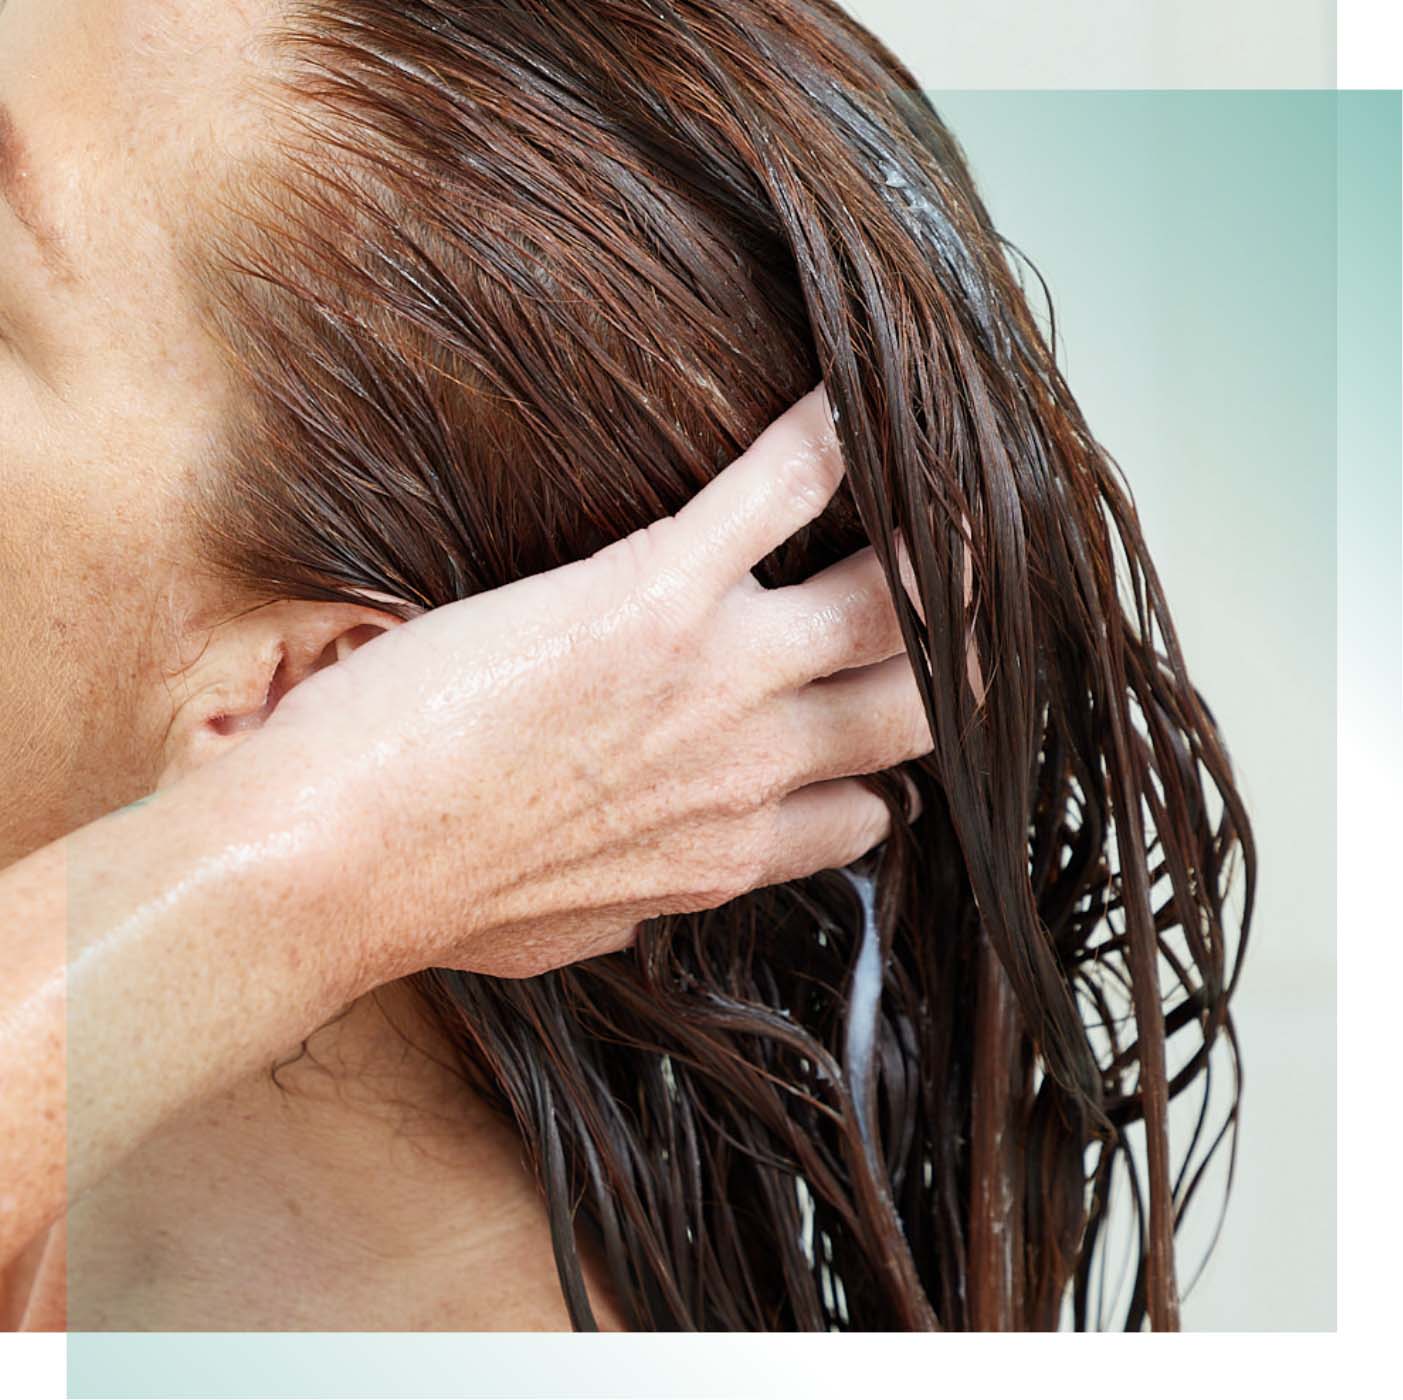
xmin=675 ymin=384 xmax=843 ymax=592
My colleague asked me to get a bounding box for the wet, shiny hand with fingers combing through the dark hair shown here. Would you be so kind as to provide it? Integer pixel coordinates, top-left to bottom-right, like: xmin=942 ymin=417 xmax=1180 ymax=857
xmin=230 ymin=387 xmax=932 ymax=982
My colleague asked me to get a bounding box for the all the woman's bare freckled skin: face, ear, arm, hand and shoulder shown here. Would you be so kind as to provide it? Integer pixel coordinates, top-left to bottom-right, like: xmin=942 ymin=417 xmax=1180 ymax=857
xmin=0 ymin=0 xmax=929 ymax=1328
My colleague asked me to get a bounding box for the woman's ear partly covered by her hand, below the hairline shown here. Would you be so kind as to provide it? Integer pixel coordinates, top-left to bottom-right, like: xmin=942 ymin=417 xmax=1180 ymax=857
xmin=156 ymin=602 xmax=403 ymax=787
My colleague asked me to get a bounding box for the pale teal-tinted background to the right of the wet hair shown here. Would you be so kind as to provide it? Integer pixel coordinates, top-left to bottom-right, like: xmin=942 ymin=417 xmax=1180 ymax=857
xmin=846 ymin=0 xmax=1337 ymax=1330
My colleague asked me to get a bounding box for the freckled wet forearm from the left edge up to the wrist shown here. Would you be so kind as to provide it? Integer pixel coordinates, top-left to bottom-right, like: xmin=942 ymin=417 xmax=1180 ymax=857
xmin=0 ymin=766 xmax=363 ymax=1263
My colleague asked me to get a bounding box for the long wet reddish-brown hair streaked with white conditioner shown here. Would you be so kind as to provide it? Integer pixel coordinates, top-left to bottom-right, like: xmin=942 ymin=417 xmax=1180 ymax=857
xmin=178 ymin=0 xmax=1256 ymax=1330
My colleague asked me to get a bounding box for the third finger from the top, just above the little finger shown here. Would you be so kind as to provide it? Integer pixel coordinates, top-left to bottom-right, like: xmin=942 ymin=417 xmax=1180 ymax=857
xmin=787 ymin=652 xmax=934 ymax=783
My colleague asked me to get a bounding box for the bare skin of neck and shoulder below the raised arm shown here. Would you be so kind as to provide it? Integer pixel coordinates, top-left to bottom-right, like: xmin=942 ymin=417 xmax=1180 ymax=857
xmin=69 ymin=983 xmax=617 ymax=1331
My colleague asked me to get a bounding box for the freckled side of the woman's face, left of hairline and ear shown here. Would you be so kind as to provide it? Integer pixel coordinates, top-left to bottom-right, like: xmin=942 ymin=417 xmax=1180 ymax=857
xmin=0 ymin=0 xmax=263 ymax=864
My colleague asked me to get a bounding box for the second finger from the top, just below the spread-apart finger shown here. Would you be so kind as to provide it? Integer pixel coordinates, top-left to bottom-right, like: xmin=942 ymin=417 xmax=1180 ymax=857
xmin=756 ymin=540 xmax=911 ymax=685
